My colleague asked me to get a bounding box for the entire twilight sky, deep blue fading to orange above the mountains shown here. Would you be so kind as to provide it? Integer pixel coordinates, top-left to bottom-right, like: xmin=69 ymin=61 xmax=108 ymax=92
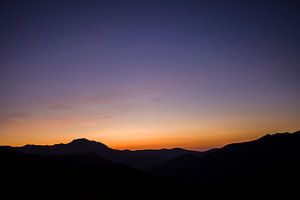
xmin=0 ymin=0 xmax=300 ymax=150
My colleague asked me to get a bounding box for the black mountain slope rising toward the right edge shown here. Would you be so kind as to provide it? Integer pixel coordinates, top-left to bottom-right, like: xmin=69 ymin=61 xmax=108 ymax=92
xmin=152 ymin=131 xmax=300 ymax=197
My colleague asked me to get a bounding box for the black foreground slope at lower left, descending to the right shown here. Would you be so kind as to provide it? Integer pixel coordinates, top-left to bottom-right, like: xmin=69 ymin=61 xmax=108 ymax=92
xmin=0 ymin=147 xmax=205 ymax=199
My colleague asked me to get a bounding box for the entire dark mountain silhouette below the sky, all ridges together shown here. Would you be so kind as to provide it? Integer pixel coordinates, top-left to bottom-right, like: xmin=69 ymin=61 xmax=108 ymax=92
xmin=0 ymin=131 xmax=300 ymax=200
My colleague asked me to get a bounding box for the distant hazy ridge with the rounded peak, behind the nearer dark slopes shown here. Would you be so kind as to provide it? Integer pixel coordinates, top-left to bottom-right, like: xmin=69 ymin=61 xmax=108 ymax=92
xmin=11 ymin=139 xmax=200 ymax=169
